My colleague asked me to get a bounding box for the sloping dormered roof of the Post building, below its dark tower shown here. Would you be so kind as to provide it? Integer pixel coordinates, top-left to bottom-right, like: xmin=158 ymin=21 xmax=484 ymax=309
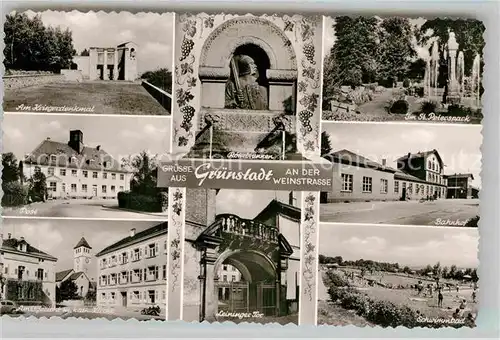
xmin=24 ymin=139 xmax=129 ymax=173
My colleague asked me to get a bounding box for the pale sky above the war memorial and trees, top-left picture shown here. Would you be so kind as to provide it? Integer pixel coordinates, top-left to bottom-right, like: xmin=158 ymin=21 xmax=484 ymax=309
xmin=27 ymin=11 xmax=173 ymax=74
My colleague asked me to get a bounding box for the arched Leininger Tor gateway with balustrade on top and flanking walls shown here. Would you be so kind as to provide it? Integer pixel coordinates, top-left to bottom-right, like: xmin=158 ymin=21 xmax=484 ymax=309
xmin=184 ymin=189 xmax=300 ymax=321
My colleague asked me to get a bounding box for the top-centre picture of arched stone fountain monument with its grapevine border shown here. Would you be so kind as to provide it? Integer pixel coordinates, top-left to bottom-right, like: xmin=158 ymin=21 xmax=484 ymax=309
xmin=173 ymin=14 xmax=322 ymax=159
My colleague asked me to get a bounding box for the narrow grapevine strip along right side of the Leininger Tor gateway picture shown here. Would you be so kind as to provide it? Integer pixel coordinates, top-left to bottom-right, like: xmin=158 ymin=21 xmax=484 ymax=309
xmin=301 ymin=192 xmax=317 ymax=301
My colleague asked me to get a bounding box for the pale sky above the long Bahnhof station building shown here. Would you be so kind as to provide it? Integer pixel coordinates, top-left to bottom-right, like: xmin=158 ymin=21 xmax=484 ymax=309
xmin=322 ymin=123 xmax=483 ymax=187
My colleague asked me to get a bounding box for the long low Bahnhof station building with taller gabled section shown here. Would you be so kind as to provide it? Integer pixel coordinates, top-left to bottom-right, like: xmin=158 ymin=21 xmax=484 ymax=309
xmin=321 ymin=150 xmax=448 ymax=203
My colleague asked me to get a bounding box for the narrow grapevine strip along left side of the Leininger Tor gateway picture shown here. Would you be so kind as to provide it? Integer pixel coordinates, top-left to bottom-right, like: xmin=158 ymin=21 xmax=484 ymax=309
xmin=167 ymin=188 xmax=184 ymax=292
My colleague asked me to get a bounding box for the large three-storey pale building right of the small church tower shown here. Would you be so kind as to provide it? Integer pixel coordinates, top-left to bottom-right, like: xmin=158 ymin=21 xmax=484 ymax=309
xmin=96 ymin=223 xmax=167 ymax=311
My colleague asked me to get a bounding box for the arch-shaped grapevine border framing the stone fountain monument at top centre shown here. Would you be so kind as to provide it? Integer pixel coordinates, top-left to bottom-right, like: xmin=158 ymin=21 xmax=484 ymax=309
xmin=173 ymin=13 xmax=322 ymax=154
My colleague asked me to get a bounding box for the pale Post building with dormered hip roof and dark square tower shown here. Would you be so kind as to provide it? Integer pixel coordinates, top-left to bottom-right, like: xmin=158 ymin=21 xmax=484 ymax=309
xmin=22 ymin=130 xmax=132 ymax=199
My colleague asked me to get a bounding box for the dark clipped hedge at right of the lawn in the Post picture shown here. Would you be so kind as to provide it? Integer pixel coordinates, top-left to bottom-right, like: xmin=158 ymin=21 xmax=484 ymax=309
xmin=118 ymin=191 xmax=168 ymax=212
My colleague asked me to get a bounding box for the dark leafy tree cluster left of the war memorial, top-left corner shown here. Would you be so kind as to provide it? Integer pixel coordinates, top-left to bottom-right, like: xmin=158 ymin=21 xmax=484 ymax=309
xmin=4 ymin=13 xmax=76 ymax=71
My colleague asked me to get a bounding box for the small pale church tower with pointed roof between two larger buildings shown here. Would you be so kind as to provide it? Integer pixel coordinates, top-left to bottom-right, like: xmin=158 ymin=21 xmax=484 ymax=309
xmin=56 ymin=237 xmax=95 ymax=298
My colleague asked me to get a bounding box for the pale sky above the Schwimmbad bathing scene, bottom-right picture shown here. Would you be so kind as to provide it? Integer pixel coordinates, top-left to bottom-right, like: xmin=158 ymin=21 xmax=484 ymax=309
xmin=319 ymin=224 xmax=479 ymax=268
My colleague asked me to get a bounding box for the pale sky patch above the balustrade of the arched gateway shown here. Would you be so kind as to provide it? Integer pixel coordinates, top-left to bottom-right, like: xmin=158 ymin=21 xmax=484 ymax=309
xmin=216 ymin=189 xmax=288 ymax=219
